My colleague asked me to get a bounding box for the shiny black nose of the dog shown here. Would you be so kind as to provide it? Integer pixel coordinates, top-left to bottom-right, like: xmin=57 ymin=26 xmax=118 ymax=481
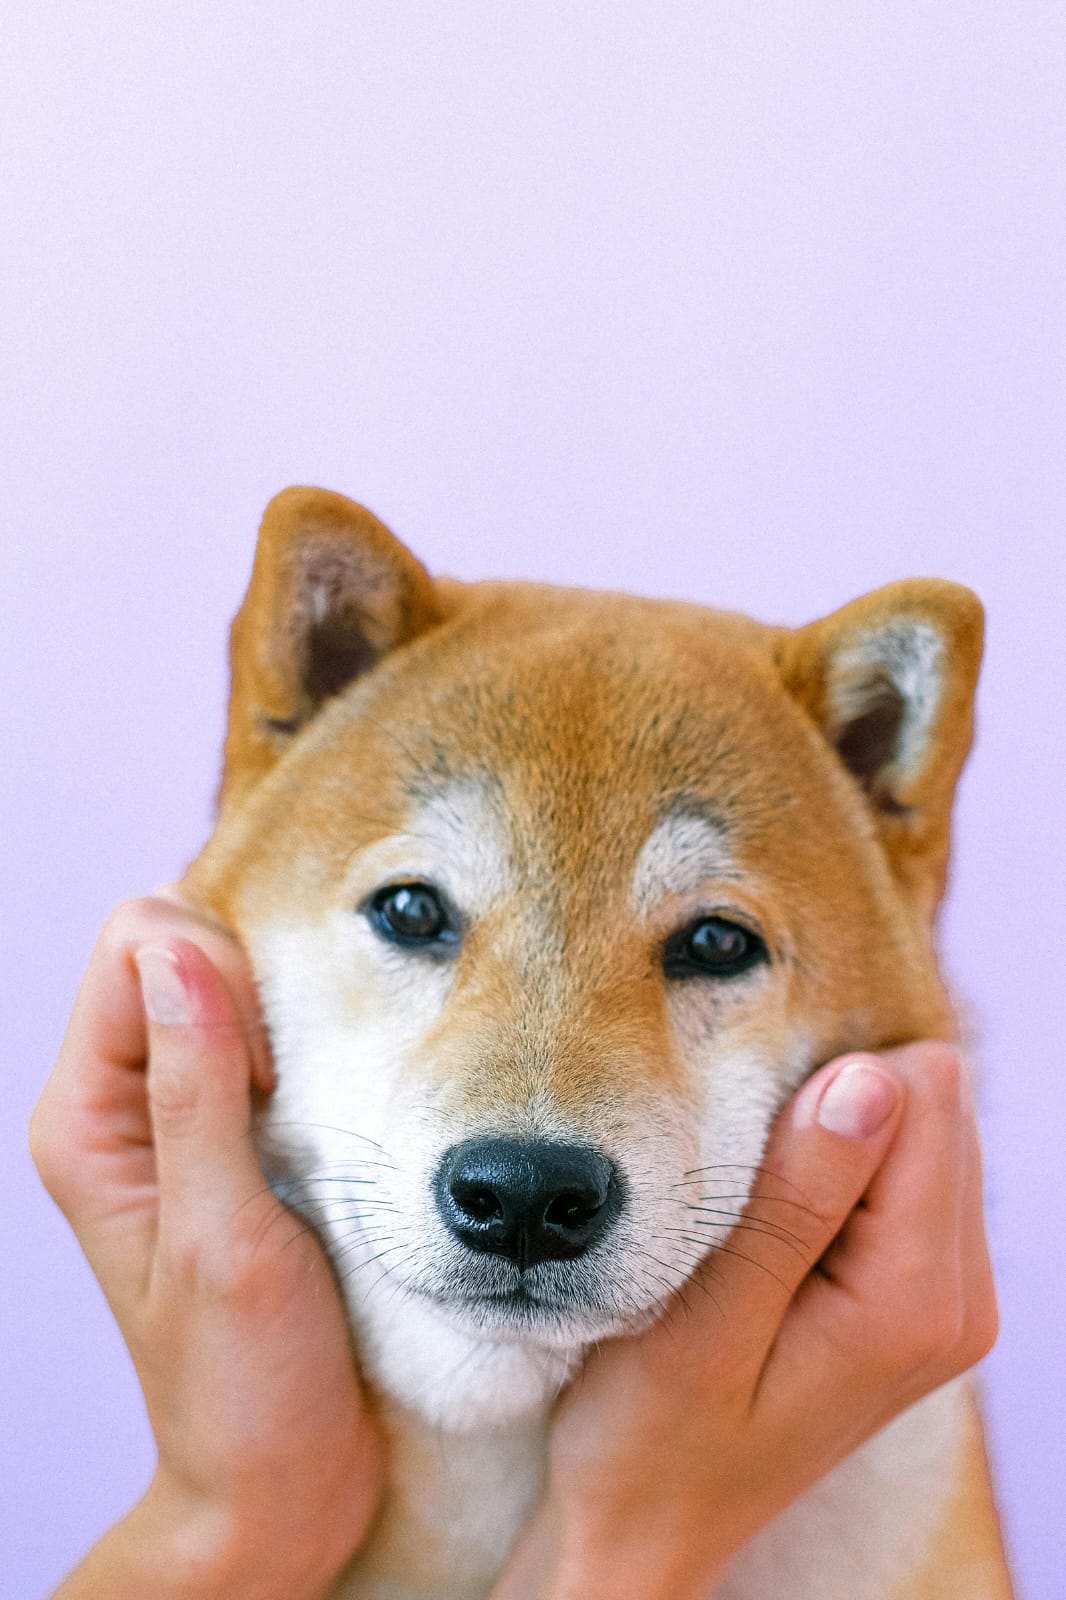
xmin=435 ymin=1139 xmax=621 ymax=1269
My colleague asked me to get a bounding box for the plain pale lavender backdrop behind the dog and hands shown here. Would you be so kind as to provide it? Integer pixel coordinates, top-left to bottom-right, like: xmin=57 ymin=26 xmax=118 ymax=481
xmin=0 ymin=0 xmax=1066 ymax=1600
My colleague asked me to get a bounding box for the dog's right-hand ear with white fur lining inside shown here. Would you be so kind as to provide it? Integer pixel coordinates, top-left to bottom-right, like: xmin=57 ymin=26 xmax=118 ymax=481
xmin=778 ymin=578 xmax=984 ymax=915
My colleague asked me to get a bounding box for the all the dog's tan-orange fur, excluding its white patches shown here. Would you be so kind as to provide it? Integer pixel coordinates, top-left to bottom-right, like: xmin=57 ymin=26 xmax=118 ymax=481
xmin=186 ymin=490 xmax=1008 ymax=1600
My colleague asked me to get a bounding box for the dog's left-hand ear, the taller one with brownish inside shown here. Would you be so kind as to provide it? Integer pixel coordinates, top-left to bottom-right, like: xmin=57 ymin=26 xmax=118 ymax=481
xmin=221 ymin=488 xmax=437 ymax=805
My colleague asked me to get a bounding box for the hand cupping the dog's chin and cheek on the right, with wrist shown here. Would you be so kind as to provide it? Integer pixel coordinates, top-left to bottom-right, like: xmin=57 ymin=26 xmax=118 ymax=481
xmin=495 ymin=1043 xmax=997 ymax=1600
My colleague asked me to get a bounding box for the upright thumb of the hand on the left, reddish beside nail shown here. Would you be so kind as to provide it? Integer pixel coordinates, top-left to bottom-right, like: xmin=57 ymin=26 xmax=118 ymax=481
xmin=136 ymin=939 xmax=266 ymax=1253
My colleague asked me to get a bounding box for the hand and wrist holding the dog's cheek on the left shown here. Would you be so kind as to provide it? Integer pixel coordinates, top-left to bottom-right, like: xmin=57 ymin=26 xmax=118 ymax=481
xmin=30 ymin=896 xmax=381 ymax=1600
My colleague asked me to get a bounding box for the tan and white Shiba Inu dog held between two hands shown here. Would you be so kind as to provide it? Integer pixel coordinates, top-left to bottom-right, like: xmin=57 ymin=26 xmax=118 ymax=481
xmin=186 ymin=488 xmax=1010 ymax=1600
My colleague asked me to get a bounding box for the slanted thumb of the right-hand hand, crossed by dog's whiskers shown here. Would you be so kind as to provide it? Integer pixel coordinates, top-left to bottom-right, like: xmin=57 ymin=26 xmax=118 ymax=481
xmin=685 ymin=1054 xmax=904 ymax=1362
